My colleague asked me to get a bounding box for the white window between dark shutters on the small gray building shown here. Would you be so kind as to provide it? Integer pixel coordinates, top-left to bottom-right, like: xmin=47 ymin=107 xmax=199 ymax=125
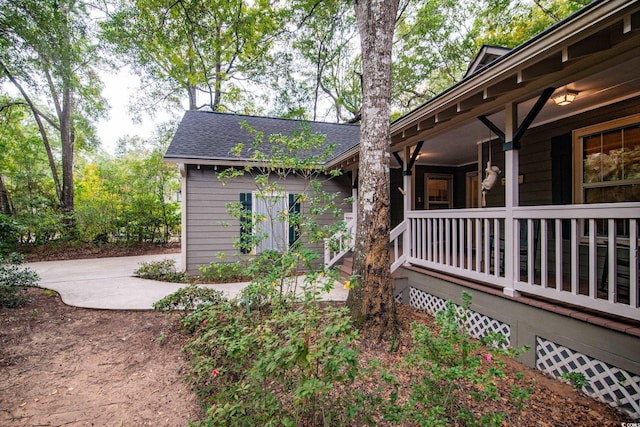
xmin=240 ymin=192 xmax=300 ymax=253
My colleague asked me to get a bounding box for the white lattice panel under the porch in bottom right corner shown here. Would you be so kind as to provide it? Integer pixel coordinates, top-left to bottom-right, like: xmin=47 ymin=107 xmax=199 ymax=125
xmin=536 ymin=337 xmax=640 ymax=419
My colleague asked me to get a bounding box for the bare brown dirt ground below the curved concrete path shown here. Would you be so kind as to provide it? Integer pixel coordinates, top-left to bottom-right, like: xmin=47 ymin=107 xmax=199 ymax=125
xmin=0 ymin=289 xmax=201 ymax=427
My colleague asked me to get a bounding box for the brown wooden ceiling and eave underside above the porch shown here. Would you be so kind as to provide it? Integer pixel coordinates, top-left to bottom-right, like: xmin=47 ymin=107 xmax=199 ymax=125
xmin=391 ymin=2 xmax=640 ymax=166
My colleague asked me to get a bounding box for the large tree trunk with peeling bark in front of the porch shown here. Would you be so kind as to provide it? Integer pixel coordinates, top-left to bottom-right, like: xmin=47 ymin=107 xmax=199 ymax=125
xmin=347 ymin=0 xmax=398 ymax=339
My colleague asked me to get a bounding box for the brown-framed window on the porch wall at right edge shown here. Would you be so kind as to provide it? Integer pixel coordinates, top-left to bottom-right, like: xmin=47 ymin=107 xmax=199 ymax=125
xmin=574 ymin=115 xmax=640 ymax=203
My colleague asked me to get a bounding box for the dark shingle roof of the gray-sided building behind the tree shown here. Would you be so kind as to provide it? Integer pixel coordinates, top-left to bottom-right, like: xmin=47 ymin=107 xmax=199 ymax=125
xmin=164 ymin=111 xmax=360 ymax=164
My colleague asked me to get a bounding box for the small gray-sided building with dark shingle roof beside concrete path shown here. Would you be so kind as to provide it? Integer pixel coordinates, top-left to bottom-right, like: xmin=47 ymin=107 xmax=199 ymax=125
xmin=164 ymin=111 xmax=360 ymax=274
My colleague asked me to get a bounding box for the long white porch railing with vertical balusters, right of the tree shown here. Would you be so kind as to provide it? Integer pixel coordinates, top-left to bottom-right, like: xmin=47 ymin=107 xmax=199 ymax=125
xmin=404 ymin=203 xmax=640 ymax=320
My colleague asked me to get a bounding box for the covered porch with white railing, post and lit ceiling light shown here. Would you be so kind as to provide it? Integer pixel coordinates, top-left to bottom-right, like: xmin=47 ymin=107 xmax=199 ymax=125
xmin=326 ymin=1 xmax=640 ymax=321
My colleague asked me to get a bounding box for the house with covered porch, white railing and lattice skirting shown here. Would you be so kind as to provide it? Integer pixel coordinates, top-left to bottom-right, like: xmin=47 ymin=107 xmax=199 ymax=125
xmin=327 ymin=0 xmax=640 ymax=418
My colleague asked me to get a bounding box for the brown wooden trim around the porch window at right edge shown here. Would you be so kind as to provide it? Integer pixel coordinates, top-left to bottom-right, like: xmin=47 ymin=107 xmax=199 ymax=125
xmin=572 ymin=113 xmax=640 ymax=204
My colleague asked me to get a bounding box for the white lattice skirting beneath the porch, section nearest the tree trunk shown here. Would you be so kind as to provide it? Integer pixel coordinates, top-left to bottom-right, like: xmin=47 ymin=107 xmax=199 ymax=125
xmin=409 ymin=288 xmax=511 ymax=347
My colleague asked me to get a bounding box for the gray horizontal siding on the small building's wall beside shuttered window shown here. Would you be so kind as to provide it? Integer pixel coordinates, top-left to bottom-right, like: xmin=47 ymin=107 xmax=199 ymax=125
xmin=184 ymin=165 xmax=351 ymax=274
